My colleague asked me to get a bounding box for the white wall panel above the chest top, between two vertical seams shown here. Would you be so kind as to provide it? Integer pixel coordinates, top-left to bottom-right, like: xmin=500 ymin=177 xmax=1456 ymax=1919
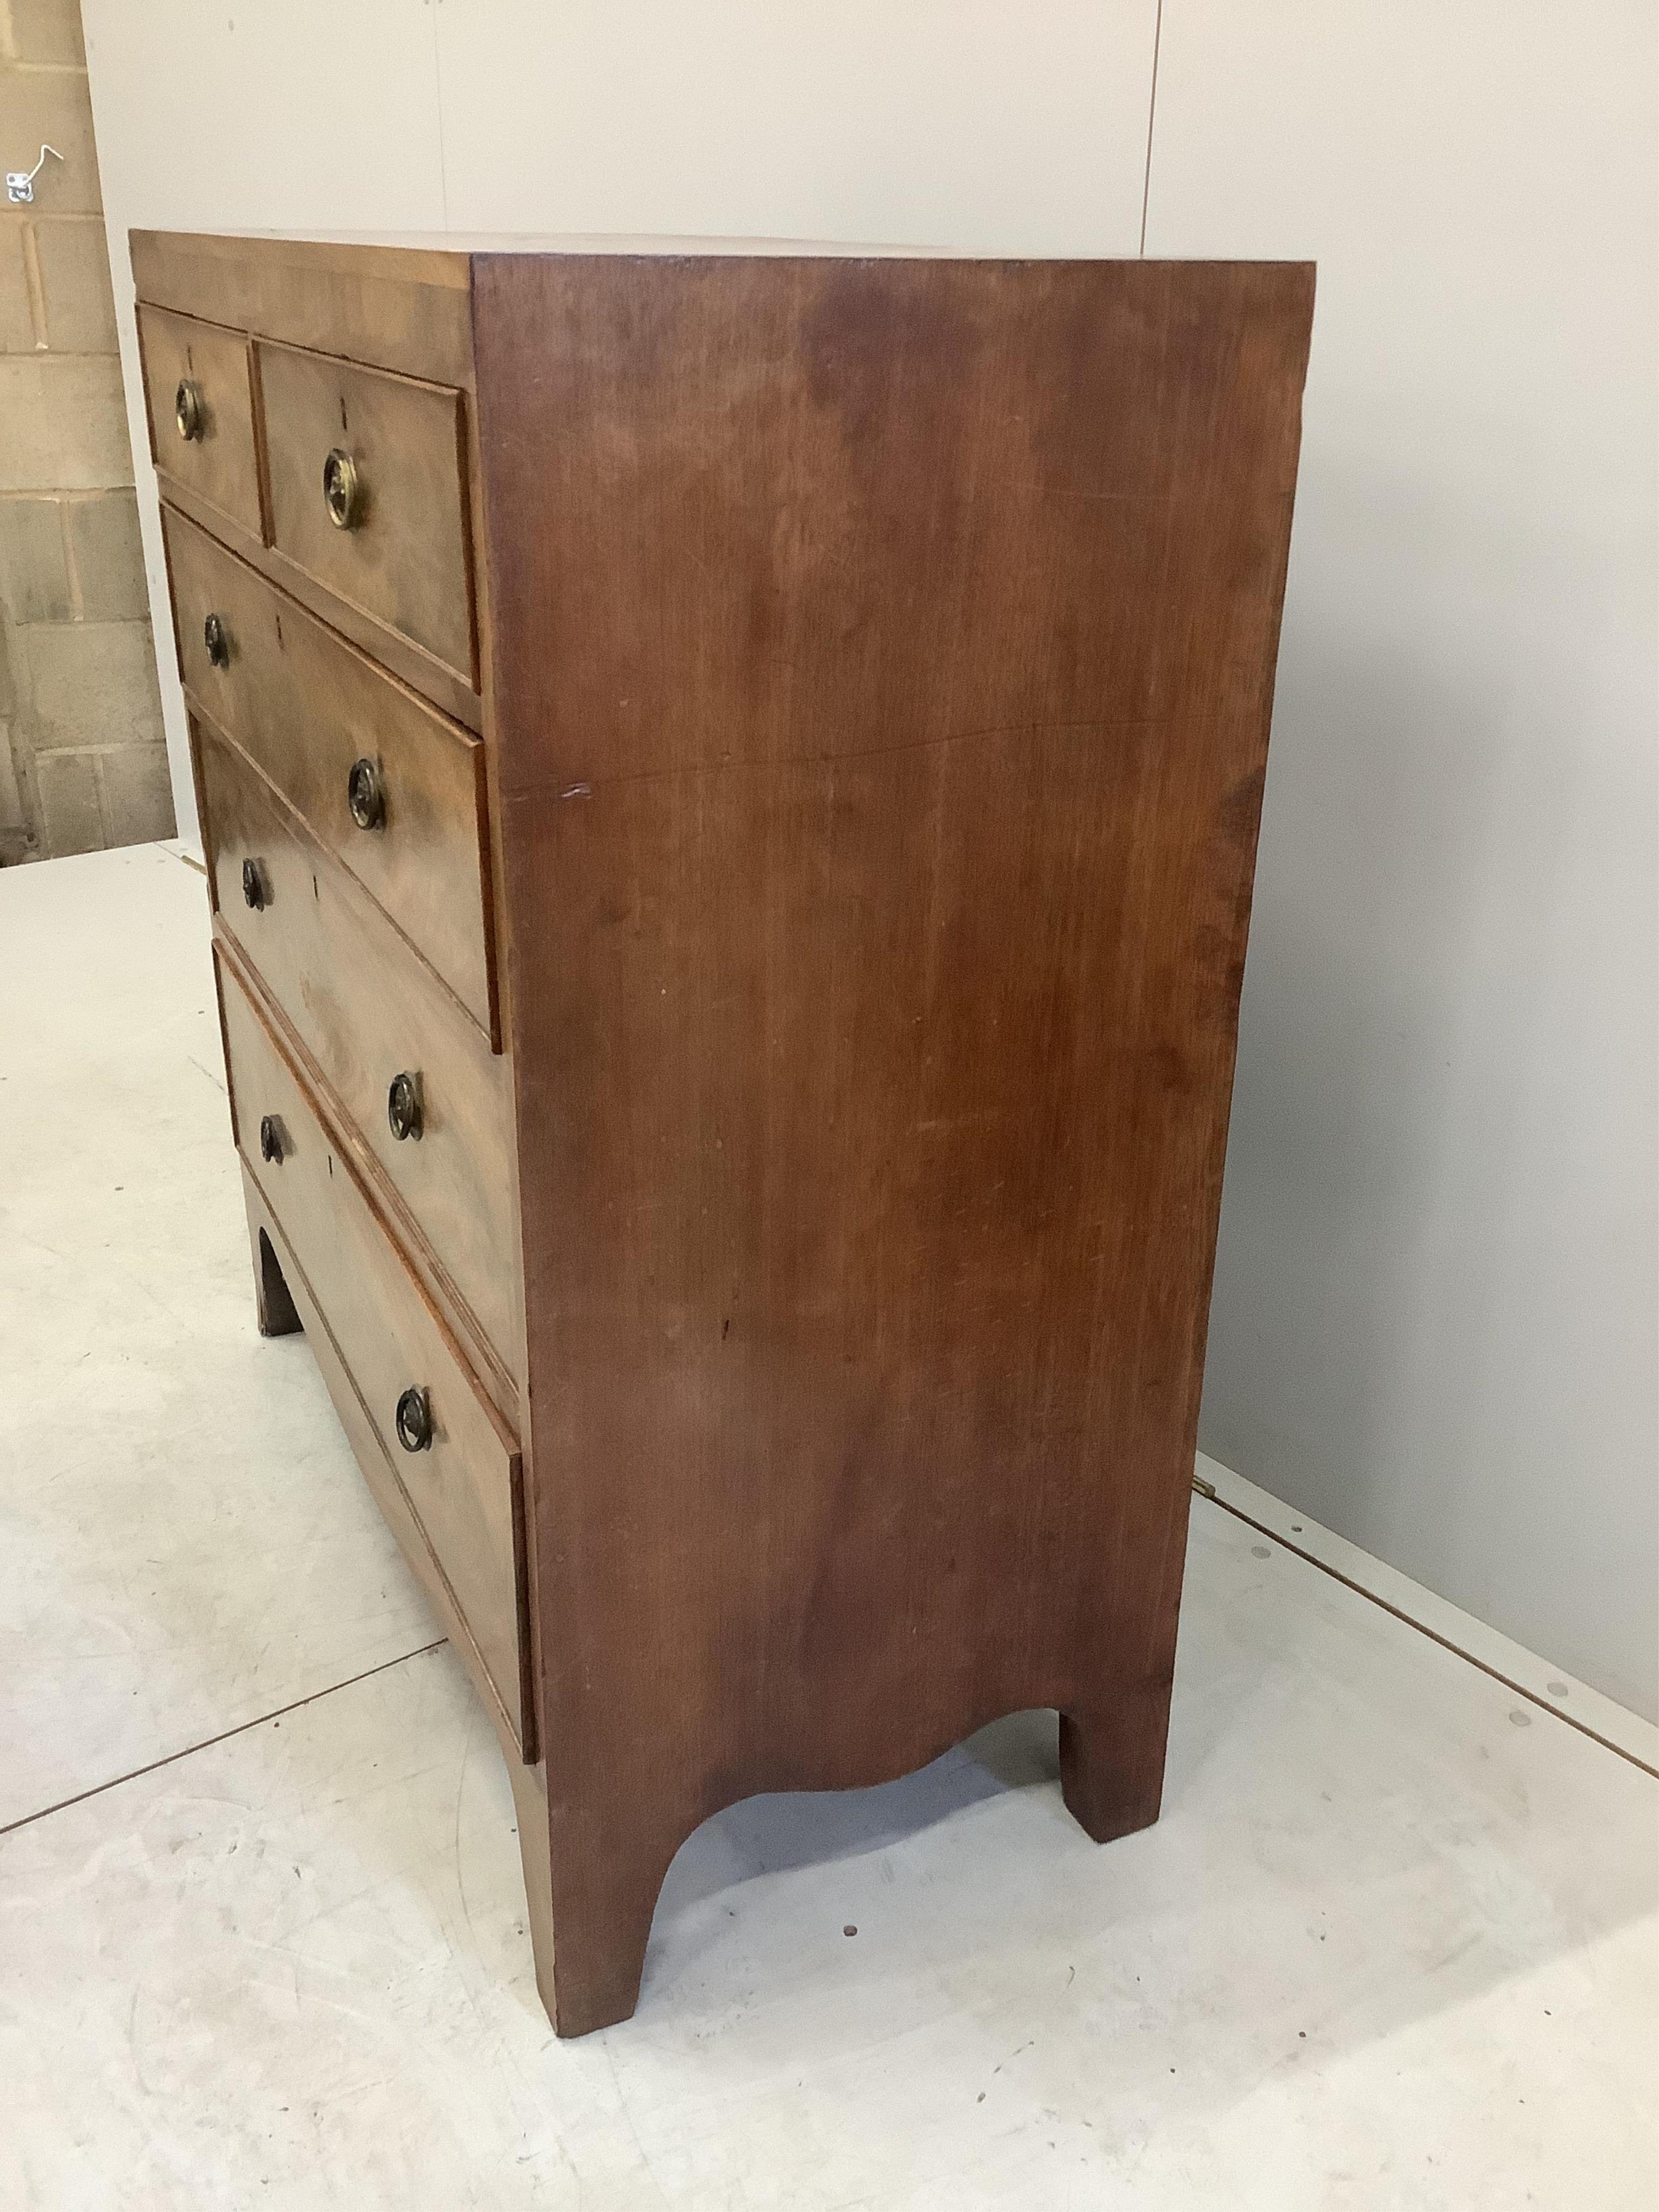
xmin=438 ymin=0 xmax=1157 ymax=254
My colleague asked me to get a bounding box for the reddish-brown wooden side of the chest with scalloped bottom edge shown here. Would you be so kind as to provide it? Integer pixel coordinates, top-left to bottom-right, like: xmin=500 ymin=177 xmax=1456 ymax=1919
xmin=474 ymin=257 xmax=1312 ymax=2028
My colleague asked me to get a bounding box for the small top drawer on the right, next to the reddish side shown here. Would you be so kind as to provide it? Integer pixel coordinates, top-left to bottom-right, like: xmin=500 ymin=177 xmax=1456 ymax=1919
xmin=257 ymin=343 xmax=478 ymax=688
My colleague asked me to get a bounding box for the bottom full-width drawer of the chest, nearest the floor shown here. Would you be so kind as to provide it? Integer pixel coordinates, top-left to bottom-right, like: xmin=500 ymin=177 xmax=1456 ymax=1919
xmin=219 ymin=960 xmax=529 ymax=1745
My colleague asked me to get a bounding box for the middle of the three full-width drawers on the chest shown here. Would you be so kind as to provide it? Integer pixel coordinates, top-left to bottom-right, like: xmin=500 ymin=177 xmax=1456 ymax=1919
xmin=194 ymin=721 xmax=520 ymax=1374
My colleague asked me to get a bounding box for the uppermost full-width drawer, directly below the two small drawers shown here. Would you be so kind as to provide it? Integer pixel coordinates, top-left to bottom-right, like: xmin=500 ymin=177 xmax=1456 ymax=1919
xmin=161 ymin=509 xmax=493 ymax=1033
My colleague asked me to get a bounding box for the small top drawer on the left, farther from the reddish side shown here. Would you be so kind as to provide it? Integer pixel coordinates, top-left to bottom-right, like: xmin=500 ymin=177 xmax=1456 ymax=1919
xmin=137 ymin=307 xmax=261 ymax=537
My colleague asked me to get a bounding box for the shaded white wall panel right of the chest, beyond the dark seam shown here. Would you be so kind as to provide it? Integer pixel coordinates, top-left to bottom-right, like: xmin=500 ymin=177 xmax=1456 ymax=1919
xmin=1146 ymin=0 xmax=1659 ymax=1716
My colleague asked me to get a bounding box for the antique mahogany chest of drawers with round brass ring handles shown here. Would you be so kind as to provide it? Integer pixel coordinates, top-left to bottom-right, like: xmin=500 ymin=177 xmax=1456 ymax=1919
xmin=133 ymin=232 xmax=1312 ymax=2035
